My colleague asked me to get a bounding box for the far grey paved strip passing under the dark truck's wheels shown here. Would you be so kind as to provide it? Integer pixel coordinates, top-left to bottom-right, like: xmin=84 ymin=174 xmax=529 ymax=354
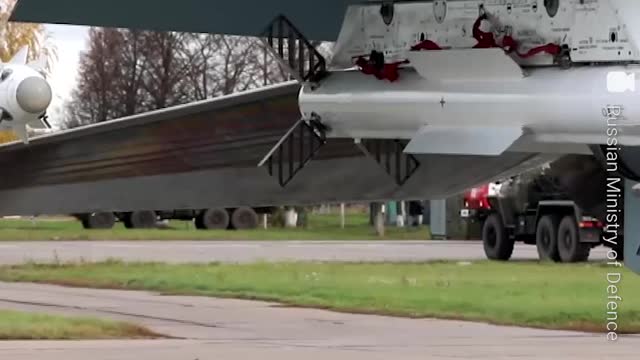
xmin=0 ymin=241 xmax=606 ymax=264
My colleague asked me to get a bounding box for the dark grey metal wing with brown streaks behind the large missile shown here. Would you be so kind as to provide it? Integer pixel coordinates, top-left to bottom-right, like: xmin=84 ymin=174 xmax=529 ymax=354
xmin=0 ymin=76 xmax=556 ymax=215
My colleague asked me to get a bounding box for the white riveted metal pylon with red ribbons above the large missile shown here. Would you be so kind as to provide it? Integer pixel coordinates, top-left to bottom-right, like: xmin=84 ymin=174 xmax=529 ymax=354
xmin=330 ymin=0 xmax=640 ymax=68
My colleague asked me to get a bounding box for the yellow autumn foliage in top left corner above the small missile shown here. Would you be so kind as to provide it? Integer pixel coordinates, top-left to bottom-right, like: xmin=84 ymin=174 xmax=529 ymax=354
xmin=0 ymin=0 xmax=56 ymax=71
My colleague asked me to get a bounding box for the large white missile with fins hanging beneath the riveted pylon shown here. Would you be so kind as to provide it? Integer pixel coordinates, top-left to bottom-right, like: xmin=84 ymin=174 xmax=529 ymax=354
xmin=299 ymin=49 xmax=640 ymax=155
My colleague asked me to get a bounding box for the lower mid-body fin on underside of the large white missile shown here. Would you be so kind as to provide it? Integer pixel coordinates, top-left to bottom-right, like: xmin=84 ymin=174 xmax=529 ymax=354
xmin=404 ymin=126 xmax=524 ymax=156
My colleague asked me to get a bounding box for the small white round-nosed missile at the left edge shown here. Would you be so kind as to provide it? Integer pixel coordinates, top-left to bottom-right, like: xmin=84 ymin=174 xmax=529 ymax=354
xmin=0 ymin=46 xmax=53 ymax=144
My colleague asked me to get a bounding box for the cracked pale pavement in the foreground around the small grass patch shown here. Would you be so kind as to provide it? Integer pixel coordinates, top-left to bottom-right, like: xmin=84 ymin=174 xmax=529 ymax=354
xmin=0 ymin=283 xmax=640 ymax=360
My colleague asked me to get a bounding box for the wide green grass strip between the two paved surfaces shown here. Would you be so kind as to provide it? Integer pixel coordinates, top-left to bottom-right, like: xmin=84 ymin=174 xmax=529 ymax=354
xmin=0 ymin=262 xmax=640 ymax=333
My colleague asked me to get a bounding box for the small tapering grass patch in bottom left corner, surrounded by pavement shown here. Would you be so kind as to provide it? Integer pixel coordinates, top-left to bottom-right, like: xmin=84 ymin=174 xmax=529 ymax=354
xmin=0 ymin=310 xmax=161 ymax=340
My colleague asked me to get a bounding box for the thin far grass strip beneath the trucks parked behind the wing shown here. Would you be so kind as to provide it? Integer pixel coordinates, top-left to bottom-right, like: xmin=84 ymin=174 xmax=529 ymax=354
xmin=0 ymin=214 xmax=430 ymax=241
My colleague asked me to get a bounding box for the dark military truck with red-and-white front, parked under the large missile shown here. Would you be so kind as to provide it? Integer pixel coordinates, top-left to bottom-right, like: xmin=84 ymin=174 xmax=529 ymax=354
xmin=461 ymin=168 xmax=603 ymax=262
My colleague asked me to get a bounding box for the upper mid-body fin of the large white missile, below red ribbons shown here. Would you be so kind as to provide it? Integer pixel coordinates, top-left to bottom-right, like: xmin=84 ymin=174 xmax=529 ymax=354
xmin=407 ymin=48 xmax=524 ymax=81
